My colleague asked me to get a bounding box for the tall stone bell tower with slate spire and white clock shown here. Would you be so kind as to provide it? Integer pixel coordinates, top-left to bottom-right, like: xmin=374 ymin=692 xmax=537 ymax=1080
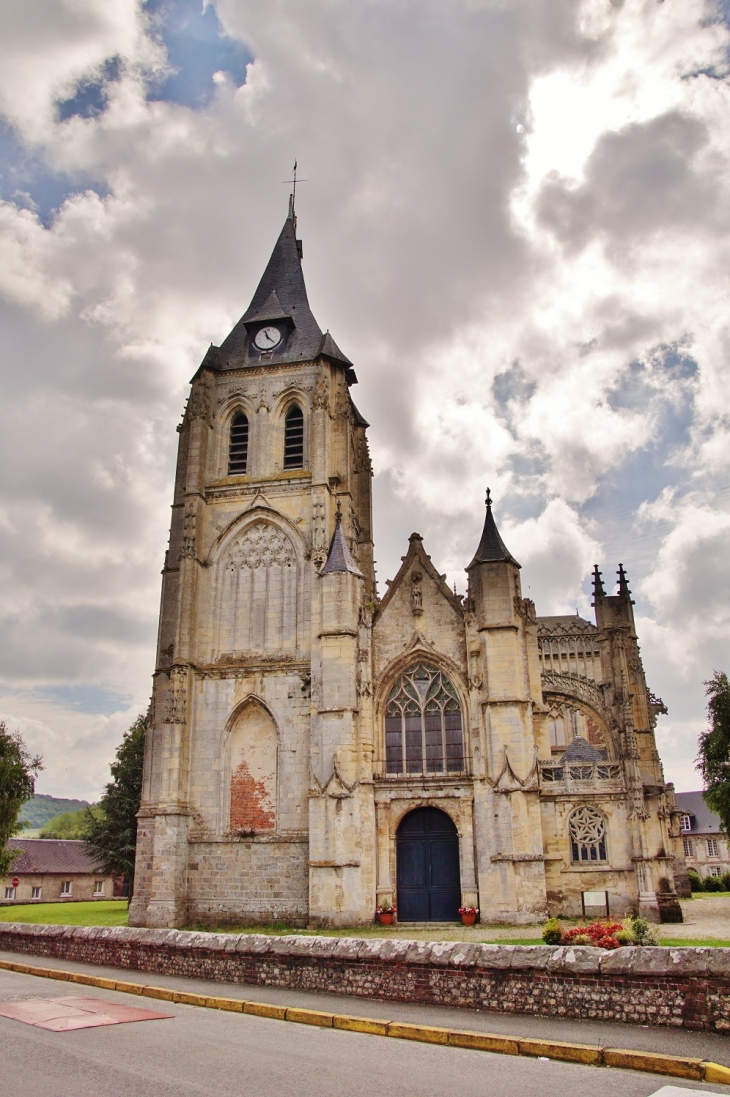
xmin=130 ymin=201 xmax=374 ymax=926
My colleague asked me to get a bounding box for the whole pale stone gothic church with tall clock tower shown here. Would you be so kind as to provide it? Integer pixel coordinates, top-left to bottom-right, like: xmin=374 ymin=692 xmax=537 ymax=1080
xmin=130 ymin=201 xmax=686 ymax=927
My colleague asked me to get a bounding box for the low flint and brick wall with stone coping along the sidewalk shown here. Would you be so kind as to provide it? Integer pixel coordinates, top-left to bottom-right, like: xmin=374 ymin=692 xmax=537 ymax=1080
xmin=0 ymin=923 xmax=730 ymax=1032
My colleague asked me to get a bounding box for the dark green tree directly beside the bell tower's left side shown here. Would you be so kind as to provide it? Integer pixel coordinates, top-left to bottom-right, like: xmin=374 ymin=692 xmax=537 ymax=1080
xmin=85 ymin=716 xmax=147 ymax=898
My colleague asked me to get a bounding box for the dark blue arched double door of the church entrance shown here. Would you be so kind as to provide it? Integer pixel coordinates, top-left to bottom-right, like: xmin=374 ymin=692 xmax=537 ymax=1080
xmin=395 ymin=807 xmax=461 ymax=921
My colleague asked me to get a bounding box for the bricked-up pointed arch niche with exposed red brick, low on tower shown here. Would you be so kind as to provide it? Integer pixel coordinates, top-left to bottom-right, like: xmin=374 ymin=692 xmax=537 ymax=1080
xmin=228 ymin=701 xmax=277 ymax=835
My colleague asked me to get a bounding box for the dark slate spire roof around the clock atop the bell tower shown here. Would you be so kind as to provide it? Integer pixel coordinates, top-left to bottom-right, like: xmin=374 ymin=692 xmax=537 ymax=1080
xmin=214 ymin=211 xmax=357 ymax=372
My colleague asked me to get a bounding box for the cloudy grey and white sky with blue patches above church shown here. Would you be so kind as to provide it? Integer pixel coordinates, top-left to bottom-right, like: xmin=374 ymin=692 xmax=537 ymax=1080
xmin=0 ymin=0 xmax=730 ymax=799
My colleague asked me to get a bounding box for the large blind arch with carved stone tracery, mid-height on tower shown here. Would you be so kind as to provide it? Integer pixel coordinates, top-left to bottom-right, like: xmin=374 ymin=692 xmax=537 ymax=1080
xmin=218 ymin=521 xmax=299 ymax=655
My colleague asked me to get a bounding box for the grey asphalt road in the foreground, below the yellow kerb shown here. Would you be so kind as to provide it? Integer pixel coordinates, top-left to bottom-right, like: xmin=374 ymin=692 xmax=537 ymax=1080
xmin=0 ymin=971 xmax=727 ymax=1097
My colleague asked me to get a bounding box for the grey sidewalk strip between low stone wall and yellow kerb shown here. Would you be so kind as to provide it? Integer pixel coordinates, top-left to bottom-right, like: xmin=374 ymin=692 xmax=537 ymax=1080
xmin=0 ymin=951 xmax=730 ymax=1066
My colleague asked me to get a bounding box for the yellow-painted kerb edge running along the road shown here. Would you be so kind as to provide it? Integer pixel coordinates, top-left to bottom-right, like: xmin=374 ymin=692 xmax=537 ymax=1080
xmin=0 ymin=960 xmax=730 ymax=1085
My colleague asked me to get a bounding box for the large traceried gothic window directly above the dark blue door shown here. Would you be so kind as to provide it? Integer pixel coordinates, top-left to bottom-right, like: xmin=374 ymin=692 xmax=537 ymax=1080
xmin=385 ymin=663 xmax=464 ymax=773
